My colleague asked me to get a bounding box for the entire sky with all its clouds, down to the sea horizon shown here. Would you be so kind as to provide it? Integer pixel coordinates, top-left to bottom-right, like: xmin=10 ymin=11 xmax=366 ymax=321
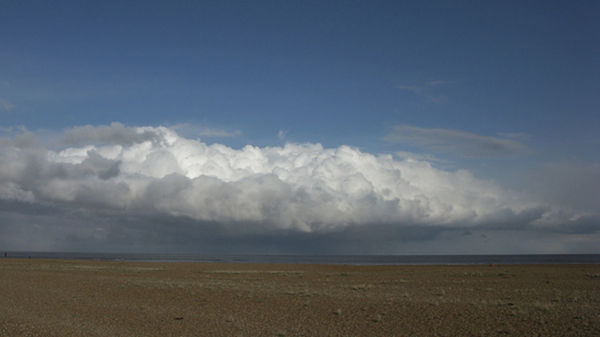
xmin=0 ymin=0 xmax=600 ymax=254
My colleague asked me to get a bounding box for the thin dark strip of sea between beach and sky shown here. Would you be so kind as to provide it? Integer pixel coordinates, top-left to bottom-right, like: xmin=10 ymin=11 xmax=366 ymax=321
xmin=2 ymin=252 xmax=600 ymax=265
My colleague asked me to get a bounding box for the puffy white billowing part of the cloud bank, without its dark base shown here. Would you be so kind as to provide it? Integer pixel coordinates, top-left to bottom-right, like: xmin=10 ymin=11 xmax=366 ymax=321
xmin=0 ymin=123 xmax=564 ymax=233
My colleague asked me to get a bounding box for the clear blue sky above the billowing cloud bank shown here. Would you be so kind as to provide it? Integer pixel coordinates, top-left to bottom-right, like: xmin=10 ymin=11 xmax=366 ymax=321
xmin=0 ymin=1 xmax=600 ymax=252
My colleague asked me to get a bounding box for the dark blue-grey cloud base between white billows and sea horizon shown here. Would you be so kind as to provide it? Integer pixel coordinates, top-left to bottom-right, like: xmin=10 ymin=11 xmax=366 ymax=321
xmin=0 ymin=201 xmax=600 ymax=255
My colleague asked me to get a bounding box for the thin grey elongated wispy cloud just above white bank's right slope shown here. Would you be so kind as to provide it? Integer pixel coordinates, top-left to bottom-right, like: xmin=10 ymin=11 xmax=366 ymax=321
xmin=385 ymin=125 xmax=530 ymax=157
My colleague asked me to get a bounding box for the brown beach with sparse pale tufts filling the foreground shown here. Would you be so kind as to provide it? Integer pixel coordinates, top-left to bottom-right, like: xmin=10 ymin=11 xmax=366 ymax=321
xmin=0 ymin=259 xmax=600 ymax=336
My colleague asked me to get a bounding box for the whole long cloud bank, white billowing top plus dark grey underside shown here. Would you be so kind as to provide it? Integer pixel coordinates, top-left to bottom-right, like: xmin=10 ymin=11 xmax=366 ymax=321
xmin=0 ymin=123 xmax=597 ymax=251
